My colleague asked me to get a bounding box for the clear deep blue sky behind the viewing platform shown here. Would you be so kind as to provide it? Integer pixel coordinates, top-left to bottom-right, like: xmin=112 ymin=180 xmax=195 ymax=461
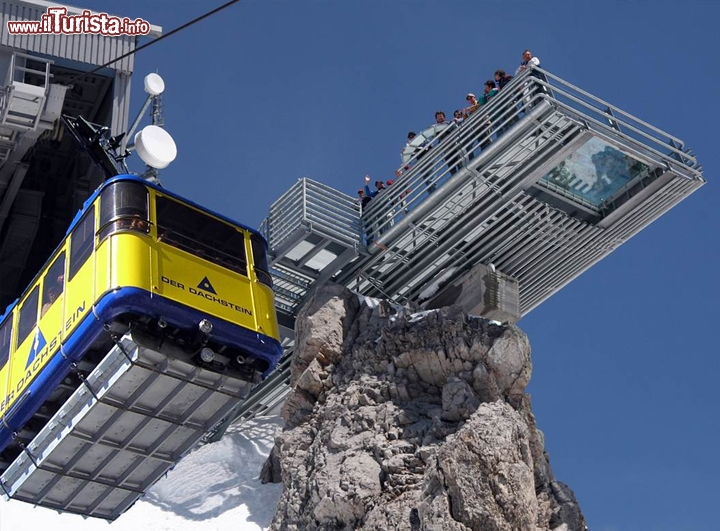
xmin=77 ymin=0 xmax=720 ymax=531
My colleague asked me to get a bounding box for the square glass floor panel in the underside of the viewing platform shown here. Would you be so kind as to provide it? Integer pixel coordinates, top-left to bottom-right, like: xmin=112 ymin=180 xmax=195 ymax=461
xmin=539 ymin=138 xmax=649 ymax=209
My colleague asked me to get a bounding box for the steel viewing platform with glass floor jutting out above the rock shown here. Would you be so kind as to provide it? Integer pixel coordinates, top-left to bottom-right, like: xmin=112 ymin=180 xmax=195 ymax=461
xmin=263 ymin=69 xmax=705 ymax=328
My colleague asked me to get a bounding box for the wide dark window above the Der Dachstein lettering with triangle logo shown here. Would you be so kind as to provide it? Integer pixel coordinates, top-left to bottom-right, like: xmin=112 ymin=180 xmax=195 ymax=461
xmin=155 ymin=195 xmax=247 ymax=275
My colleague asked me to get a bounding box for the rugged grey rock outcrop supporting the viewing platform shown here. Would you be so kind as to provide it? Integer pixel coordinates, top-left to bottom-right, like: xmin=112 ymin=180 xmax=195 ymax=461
xmin=262 ymin=286 xmax=586 ymax=531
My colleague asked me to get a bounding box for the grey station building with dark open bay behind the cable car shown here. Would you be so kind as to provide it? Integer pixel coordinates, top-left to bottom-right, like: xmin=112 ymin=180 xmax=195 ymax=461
xmin=0 ymin=0 xmax=161 ymax=309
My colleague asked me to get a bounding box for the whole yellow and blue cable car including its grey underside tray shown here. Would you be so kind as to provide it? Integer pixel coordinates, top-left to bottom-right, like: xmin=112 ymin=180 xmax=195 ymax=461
xmin=0 ymin=115 xmax=282 ymax=520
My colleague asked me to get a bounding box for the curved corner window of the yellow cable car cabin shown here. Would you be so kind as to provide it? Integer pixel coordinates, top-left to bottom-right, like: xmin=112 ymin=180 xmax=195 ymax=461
xmin=99 ymin=182 xmax=150 ymax=240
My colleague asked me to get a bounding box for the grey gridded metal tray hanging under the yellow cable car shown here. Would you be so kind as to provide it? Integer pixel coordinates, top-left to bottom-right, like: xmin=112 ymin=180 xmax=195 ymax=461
xmin=0 ymin=330 xmax=254 ymax=520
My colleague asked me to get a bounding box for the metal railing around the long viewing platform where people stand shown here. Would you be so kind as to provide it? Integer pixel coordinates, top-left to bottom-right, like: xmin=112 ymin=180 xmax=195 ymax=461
xmin=362 ymin=68 xmax=702 ymax=248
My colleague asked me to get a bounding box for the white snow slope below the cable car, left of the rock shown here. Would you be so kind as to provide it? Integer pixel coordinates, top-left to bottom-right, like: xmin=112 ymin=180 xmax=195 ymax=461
xmin=0 ymin=417 xmax=282 ymax=531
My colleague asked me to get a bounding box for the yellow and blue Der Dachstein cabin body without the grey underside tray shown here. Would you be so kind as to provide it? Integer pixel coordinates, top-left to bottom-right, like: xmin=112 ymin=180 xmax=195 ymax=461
xmin=0 ymin=175 xmax=282 ymax=462
